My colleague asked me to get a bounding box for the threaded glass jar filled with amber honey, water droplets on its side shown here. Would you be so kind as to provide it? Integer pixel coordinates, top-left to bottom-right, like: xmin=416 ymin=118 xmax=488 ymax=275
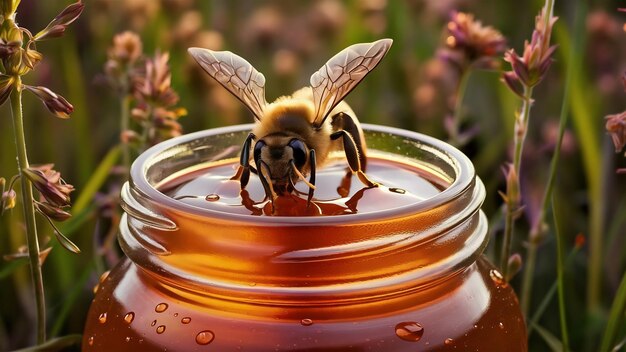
xmin=83 ymin=125 xmax=527 ymax=352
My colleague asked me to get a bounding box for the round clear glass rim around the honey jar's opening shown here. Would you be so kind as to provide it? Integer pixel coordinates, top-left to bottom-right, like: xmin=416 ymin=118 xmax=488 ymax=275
xmin=130 ymin=123 xmax=475 ymax=226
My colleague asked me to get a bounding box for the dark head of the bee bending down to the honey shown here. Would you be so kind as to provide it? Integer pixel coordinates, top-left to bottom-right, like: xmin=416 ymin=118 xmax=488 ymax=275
xmin=254 ymin=135 xmax=309 ymax=191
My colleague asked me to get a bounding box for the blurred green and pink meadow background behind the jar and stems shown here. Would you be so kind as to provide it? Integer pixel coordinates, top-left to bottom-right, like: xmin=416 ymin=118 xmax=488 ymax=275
xmin=0 ymin=0 xmax=626 ymax=351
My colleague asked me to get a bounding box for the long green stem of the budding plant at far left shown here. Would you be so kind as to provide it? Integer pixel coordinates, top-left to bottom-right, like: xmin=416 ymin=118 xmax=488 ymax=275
xmin=11 ymin=77 xmax=46 ymax=344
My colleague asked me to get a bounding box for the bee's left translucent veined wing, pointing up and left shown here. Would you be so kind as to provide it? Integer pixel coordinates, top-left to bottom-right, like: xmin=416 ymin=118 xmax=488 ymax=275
xmin=188 ymin=48 xmax=267 ymax=120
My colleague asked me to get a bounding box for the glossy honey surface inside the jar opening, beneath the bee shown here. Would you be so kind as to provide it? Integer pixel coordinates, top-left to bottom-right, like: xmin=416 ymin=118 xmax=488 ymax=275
xmin=159 ymin=158 xmax=448 ymax=216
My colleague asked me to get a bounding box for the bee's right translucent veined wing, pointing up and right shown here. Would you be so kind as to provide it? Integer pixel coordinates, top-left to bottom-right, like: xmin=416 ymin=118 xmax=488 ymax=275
xmin=310 ymin=39 xmax=393 ymax=127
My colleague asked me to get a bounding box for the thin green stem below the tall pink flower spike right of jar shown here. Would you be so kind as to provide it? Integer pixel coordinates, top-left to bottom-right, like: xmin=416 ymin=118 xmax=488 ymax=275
xmin=500 ymin=86 xmax=533 ymax=278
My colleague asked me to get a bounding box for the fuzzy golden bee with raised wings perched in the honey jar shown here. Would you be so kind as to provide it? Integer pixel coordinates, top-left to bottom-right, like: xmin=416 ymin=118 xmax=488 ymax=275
xmin=188 ymin=39 xmax=393 ymax=204
